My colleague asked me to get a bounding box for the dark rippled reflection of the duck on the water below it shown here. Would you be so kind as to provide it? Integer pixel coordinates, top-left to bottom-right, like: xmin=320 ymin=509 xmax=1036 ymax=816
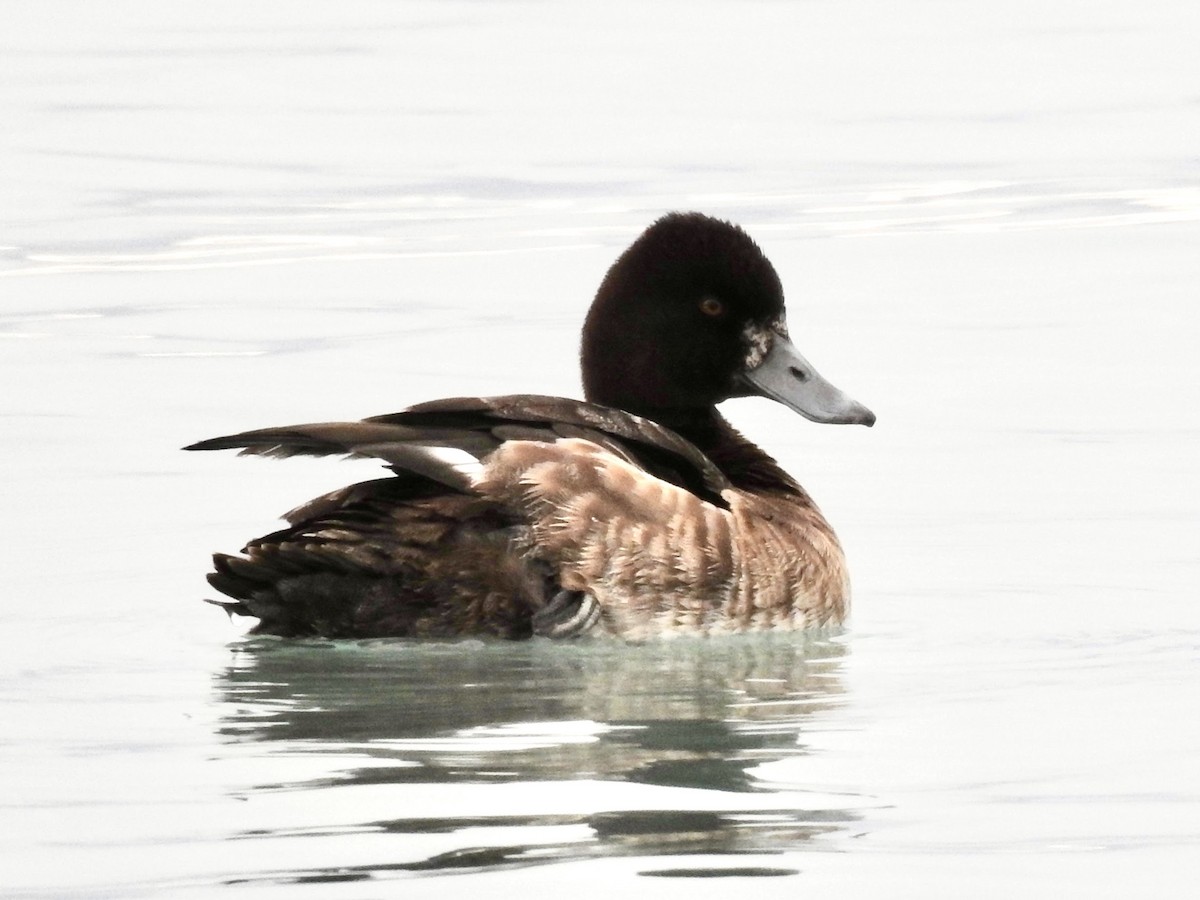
xmin=217 ymin=635 xmax=860 ymax=881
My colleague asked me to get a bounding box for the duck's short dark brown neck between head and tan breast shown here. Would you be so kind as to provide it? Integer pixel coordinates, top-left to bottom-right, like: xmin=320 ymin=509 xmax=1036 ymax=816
xmin=652 ymin=407 xmax=808 ymax=499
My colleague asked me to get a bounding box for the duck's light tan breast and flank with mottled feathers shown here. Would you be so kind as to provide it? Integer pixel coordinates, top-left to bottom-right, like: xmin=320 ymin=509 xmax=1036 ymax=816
xmin=475 ymin=439 xmax=848 ymax=640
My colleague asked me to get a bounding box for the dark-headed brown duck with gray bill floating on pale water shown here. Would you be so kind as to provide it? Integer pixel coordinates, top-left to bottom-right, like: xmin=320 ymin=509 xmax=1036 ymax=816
xmin=185 ymin=212 xmax=875 ymax=642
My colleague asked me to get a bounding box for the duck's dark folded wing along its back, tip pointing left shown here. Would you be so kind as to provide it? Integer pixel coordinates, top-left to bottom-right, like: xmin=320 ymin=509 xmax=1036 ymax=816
xmin=185 ymin=394 xmax=730 ymax=508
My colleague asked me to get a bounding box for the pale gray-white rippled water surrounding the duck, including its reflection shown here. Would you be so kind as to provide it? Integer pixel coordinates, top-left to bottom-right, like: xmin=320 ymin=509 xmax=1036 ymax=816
xmin=0 ymin=0 xmax=1200 ymax=898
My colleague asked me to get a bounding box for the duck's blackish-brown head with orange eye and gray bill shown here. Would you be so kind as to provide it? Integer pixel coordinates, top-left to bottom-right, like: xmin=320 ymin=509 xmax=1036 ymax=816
xmin=581 ymin=212 xmax=875 ymax=425
